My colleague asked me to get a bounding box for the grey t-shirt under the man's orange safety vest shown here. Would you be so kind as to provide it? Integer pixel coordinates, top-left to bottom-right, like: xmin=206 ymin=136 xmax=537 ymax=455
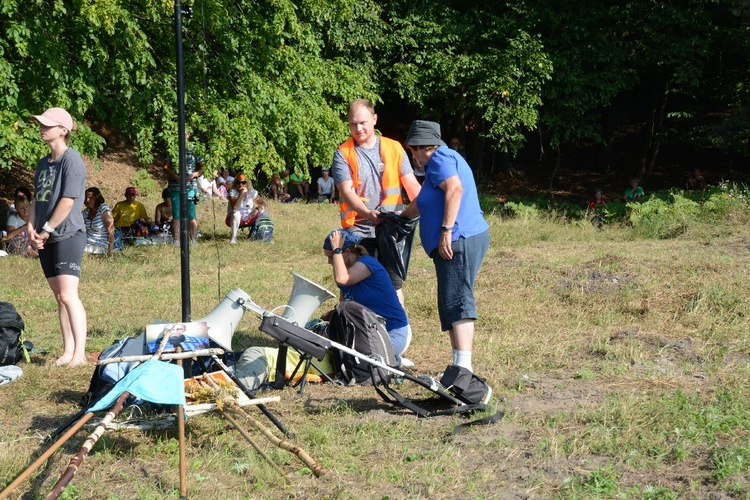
xmin=331 ymin=136 xmax=414 ymax=238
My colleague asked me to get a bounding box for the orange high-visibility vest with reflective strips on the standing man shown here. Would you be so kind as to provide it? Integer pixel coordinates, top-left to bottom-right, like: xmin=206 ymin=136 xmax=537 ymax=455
xmin=339 ymin=137 xmax=404 ymax=229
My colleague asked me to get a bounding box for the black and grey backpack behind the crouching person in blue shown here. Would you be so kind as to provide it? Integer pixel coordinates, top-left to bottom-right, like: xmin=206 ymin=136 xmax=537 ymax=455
xmin=328 ymin=300 xmax=396 ymax=385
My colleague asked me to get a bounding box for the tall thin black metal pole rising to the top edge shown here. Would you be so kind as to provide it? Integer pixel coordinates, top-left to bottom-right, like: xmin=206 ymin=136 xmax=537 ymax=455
xmin=174 ymin=0 xmax=192 ymax=323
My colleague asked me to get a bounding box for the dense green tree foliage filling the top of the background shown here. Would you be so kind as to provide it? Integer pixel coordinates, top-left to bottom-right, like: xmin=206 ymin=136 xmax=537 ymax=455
xmin=0 ymin=0 xmax=750 ymax=180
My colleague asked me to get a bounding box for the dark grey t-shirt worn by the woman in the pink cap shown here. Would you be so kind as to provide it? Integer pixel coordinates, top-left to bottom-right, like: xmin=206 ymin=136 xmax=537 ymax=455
xmin=34 ymin=148 xmax=86 ymax=243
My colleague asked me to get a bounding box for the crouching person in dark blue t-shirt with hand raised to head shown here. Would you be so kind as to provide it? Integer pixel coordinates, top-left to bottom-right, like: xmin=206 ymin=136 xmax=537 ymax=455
xmin=323 ymin=229 xmax=414 ymax=367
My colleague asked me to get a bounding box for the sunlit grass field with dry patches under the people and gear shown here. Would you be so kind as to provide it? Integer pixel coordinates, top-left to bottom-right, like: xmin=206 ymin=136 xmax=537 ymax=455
xmin=0 ymin=197 xmax=750 ymax=499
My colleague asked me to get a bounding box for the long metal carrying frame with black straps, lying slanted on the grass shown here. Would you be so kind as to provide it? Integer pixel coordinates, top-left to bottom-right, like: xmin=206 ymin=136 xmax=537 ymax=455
xmin=260 ymin=311 xmax=492 ymax=417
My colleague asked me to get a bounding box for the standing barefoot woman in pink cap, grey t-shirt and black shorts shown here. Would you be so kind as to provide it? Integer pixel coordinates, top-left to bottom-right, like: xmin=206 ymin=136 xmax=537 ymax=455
xmin=28 ymin=108 xmax=86 ymax=366
